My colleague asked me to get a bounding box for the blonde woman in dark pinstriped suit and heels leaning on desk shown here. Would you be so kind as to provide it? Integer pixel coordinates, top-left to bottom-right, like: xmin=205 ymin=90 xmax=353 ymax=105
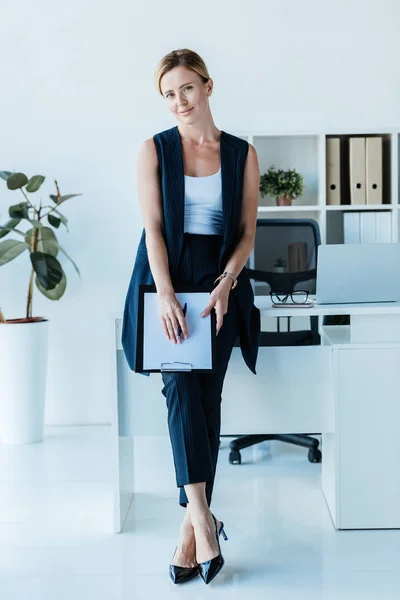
xmin=122 ymin=49 xmax=260 ymax=583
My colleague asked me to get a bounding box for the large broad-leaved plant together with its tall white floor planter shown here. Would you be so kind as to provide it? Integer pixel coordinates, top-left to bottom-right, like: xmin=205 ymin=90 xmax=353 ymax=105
xmin=0 ymin=171 xmax=80 ymax=444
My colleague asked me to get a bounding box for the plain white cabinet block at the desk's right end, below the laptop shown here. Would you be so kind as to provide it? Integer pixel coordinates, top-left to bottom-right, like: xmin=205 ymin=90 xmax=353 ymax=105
xmin=322 ymin=344 xmax=400 ymax=529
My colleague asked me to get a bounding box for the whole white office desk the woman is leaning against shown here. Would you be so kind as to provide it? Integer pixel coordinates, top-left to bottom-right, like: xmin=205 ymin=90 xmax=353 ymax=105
xmin=110 ymin=296 xmax=400 ymax=531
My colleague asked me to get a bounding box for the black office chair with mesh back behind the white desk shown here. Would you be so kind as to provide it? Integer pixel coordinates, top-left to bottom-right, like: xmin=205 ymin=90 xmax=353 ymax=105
xmin=229 ymin=219 xmax=322 ymax=464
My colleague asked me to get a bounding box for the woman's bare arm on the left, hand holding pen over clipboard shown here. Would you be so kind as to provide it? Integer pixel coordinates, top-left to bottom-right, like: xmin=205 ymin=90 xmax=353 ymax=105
xmin=137 ymin=138 xmax=187 ymax=342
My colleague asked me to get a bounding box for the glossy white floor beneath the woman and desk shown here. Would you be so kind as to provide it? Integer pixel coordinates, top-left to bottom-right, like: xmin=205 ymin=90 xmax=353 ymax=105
xmin=0 ymin=427 xmax=400 ymax=600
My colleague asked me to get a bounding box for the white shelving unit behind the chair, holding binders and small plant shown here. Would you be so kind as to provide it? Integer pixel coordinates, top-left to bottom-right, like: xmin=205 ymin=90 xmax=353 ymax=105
xmin=233 ymin=127 xmax=400 ymax=244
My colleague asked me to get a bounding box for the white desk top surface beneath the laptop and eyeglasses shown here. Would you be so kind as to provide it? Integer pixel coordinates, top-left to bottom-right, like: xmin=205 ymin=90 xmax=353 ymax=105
xmin=254 ymin=296 xmax=400 ymax=317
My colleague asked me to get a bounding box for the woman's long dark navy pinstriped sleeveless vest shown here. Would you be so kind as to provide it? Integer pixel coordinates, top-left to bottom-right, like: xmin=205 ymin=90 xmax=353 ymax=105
xmin=122 ymin=126 xmax=260 ymax=373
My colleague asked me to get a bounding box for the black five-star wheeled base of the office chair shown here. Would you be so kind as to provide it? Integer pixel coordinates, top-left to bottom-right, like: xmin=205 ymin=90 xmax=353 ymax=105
xmin=229 ymin=433 xmax=322 ymax=465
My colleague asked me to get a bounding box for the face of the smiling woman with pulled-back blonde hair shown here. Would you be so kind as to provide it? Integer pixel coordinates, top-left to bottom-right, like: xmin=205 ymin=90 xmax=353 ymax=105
xmin=161 ymin=67 xmax=212 ymax=124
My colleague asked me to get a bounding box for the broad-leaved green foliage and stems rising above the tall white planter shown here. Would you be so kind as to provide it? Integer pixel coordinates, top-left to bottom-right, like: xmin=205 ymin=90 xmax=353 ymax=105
xmin=0 ymin=171 xmax=80 ymax=322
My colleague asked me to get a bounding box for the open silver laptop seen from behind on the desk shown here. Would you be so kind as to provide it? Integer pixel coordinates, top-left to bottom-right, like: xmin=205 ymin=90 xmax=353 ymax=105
xmin=316 ymin=243 xmax=400 ymax=304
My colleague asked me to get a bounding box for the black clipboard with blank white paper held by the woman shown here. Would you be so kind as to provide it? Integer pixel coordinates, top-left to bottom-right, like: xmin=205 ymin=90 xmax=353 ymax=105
xmin=135 ymin=285 xmax=216 ymax=373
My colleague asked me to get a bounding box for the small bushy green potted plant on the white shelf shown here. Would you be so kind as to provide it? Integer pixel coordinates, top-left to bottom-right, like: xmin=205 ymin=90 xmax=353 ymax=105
xmin=260 ymin=165 xmax=304 ymax=206
